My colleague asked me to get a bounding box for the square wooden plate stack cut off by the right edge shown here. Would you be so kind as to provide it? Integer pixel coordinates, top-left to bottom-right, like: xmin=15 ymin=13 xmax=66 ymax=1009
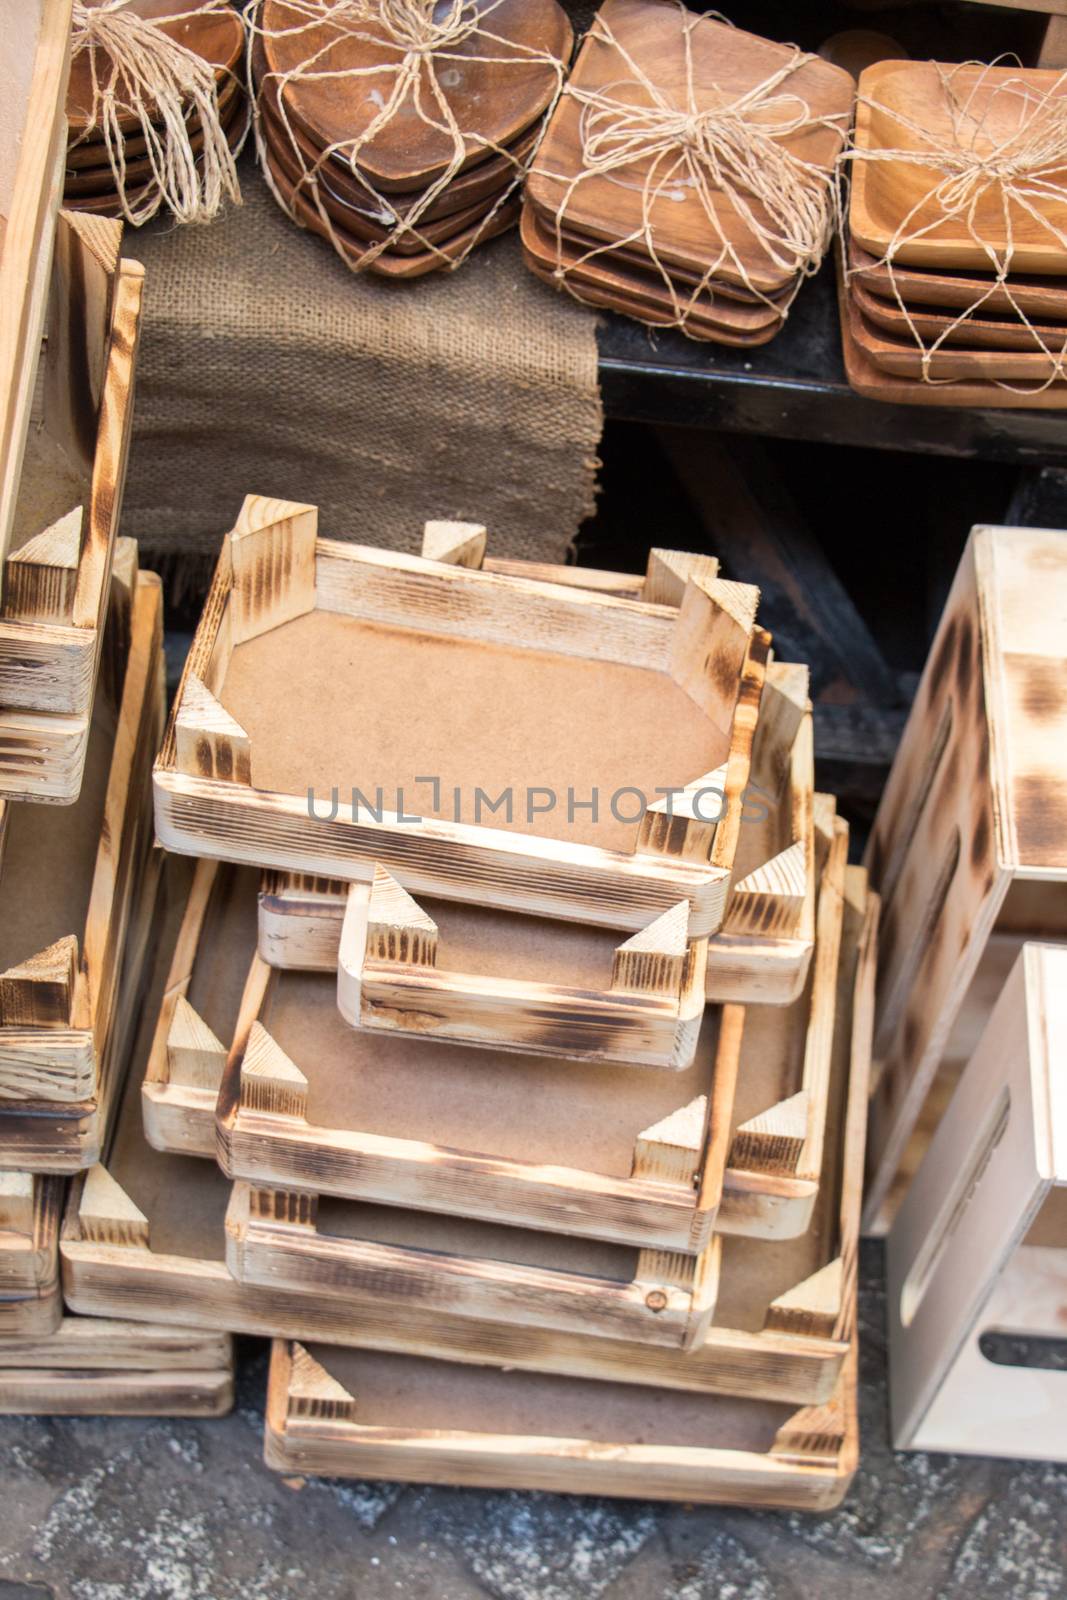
xmin=841 ymin=61 xmax=1067 ymax=408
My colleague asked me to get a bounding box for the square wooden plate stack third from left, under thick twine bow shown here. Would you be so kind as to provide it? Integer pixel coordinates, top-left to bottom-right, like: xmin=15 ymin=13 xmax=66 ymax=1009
xmin=522 ymin=0 xmax=854 ymax=346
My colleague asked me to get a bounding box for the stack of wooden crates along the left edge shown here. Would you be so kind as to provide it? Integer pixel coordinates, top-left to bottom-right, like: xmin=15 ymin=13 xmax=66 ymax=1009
xmin=0 ymin=0 xmax=232 ymax=1413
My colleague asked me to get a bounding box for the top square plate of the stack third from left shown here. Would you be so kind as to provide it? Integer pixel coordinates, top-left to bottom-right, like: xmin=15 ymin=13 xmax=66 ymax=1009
xmin=526 ymin=0 xmax=854 ymax=293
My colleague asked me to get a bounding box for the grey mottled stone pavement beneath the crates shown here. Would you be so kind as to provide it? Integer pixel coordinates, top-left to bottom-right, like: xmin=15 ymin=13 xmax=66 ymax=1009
xmin=0 ymin=1246 xmax=1067 ymax=1600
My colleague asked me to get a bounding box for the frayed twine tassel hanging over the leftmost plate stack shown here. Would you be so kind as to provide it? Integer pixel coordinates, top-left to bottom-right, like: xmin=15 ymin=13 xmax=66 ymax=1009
xmin=70 ymin=0 xmax=240 ymax=224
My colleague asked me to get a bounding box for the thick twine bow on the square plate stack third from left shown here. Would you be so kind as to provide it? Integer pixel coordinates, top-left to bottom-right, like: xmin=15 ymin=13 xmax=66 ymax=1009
xmin=539 ymin=0 xmax=848 ymax=333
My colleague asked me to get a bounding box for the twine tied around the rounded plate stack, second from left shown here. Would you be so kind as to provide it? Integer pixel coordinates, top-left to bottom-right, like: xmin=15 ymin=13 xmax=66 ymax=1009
xmin=245 ymin=0 xmax=565 ymax=272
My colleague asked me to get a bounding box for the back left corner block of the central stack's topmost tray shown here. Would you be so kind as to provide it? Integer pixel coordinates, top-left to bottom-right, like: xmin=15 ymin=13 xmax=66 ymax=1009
xmin=230 ymin=494 xmax=318 ymax=645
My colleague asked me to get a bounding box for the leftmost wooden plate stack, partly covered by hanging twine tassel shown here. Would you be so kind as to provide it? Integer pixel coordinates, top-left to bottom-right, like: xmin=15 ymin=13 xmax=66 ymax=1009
xmin=64 ymin=0 xmax=248 ymax=216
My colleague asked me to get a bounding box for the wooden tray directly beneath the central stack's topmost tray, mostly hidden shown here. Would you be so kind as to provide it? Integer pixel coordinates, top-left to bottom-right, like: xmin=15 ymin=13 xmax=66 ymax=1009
xmin=252 ymin=523 xmax=816 ymax=1005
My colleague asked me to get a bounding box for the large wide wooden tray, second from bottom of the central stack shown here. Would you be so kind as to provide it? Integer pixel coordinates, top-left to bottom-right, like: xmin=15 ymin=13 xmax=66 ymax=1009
xmin=61 ymin=851 xmax=870 ymax=1405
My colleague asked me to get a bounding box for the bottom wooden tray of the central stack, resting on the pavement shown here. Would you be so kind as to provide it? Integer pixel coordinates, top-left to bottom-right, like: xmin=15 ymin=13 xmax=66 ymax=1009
xmin=266 ymin=1341 xmax=859 ymax=1510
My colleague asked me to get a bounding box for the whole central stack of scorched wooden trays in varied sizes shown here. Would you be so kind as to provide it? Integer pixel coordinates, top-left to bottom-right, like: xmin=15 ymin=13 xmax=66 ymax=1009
xmin=61 ymin=498 xmax=877 ymax=1507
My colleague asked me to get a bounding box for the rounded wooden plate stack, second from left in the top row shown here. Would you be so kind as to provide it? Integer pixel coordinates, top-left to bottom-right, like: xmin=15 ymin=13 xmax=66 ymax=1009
xmin=253 ymin=0 xmax=573 ymax=278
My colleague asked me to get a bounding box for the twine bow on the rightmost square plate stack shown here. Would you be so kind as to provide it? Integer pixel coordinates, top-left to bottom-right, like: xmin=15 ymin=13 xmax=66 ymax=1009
xmin=843 ymin=58 xmax=1067 ymax=394
